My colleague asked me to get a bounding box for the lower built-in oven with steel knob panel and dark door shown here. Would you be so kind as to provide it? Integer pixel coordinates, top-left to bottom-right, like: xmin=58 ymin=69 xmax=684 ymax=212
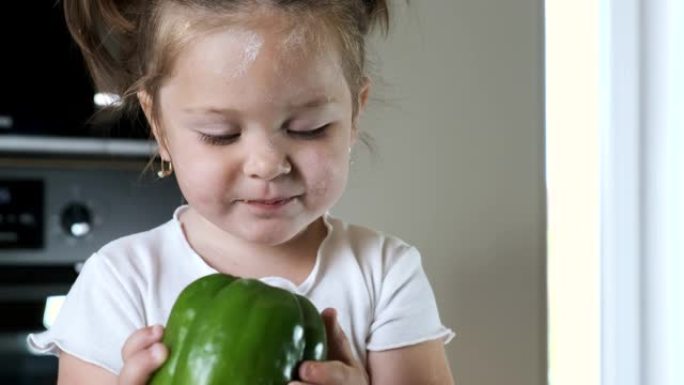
xmin=0 ymin=158 xmax=181 ymax=385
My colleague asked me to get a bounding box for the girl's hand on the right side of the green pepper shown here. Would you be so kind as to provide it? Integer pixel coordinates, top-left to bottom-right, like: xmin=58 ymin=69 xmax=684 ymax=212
xmin=289 ymin=308 xmax=370 ymax=385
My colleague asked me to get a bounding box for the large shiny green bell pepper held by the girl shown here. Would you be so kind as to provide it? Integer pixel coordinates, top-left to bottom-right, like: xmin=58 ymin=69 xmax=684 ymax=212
xmin=150 ymin=274 xmax=327 ymax=385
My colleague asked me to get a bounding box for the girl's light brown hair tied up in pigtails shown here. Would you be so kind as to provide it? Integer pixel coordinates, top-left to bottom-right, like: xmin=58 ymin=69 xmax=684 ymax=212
xmin=64 ymin=0 xmax=389 ymax=129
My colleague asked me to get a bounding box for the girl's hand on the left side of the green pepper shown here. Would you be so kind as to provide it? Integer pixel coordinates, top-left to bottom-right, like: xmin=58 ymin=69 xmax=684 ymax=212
xmin=118 ymin=325 xmax=168 ymax=385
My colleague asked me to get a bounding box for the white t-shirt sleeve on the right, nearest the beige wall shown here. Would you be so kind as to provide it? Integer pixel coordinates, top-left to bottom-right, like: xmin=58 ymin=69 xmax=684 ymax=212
xmin=367 ymin=247 xmax=454 ymax=351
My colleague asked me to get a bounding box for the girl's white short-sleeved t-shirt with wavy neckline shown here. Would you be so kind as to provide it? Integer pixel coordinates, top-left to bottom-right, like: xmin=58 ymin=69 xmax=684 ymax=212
xmin=28 ymin=206 xmax=454 ymax=374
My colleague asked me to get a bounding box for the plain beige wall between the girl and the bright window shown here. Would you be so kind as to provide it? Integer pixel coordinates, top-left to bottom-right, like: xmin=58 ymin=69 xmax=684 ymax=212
xmin=334 ymin=0 xmax=546 ymax=385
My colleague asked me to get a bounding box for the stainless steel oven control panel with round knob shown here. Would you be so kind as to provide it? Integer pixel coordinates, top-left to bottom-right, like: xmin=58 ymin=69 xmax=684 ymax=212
xmin=0 ymin=160 xmax=182 ymax=266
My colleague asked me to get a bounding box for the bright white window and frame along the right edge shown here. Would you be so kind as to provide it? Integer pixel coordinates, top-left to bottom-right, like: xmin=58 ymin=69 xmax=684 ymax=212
xmin=546 ymin=0 xmax=684 ymax=385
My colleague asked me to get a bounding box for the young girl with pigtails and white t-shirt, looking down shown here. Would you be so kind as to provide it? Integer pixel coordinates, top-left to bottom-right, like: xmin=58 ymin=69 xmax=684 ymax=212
xmin=29 ymin=0 xmax=453 ymax=385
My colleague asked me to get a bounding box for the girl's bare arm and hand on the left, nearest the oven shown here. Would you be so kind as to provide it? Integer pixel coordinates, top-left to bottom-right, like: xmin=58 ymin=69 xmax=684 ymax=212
xmin=57 ymin=326 xmax=168 ymax=385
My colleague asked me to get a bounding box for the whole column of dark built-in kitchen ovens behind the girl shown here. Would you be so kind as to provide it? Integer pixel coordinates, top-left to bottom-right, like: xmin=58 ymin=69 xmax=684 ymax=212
xmin=0 ymin=0 xmax=181 ymax=385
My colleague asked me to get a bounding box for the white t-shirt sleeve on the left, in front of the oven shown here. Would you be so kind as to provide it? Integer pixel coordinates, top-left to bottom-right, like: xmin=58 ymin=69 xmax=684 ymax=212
xmin=27 ymin=250 xmax=144 ymax=374
